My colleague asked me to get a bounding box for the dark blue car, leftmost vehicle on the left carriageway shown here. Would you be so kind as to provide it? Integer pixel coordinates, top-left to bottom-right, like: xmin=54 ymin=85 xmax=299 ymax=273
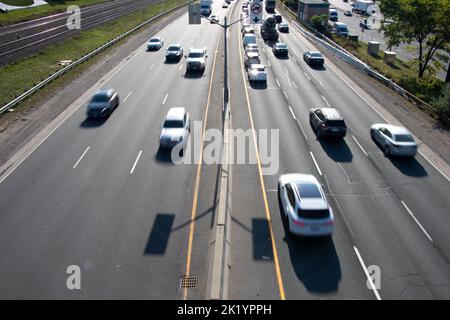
xmin=86 ymin=89 xmax=120 ymax=118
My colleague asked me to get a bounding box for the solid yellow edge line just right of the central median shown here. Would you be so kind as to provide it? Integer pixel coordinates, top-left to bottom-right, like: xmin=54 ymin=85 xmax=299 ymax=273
xmin=238 ymin=20 xmax=286 ymax=300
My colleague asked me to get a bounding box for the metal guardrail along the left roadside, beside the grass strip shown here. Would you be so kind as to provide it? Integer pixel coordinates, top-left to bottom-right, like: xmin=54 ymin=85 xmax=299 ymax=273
xmin=0 ymin=0 xmax=195 ymax=115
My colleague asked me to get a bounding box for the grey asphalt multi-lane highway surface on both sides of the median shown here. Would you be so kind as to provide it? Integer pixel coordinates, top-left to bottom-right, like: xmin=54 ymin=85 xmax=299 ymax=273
xmin=0 ymin=0 xmax=450 ymax=299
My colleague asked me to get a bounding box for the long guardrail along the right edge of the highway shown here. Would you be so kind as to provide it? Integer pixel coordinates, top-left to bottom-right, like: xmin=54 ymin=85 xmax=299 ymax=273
xmin=281 ymin=2 xmax=437 ymax=112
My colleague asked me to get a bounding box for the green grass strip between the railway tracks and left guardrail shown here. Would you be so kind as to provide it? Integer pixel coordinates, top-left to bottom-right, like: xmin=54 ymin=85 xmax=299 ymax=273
xmin=0 ymin=0 xmax=186 ymax=107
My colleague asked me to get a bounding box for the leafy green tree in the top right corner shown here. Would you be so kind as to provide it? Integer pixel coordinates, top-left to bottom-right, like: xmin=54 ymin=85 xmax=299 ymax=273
xmin=380 ymin=0 xmax=450 ymax=78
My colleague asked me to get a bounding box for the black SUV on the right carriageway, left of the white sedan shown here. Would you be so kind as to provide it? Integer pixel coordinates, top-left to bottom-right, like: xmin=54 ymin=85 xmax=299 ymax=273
xmin=309 ymin=108 xmax=347 ymax=138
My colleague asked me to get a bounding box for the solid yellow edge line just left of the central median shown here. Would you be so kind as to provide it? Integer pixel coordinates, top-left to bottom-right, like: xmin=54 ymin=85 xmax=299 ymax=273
xmin=183 ymin=24 xmax=223 ymax=300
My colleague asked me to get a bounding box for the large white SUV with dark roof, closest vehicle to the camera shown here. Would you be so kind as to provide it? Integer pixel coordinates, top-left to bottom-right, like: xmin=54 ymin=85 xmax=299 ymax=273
xmin=278 ymin=173 xmax=334 ymax=236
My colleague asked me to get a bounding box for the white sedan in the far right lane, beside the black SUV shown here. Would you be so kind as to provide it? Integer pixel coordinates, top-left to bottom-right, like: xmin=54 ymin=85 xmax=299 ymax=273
xmin=370 ymin=123 xmax=417 ymax=157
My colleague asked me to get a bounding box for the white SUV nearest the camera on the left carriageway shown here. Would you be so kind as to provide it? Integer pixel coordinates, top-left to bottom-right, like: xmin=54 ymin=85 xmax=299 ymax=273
xmin=159 ymin=108 xmax=191 ymax=149
